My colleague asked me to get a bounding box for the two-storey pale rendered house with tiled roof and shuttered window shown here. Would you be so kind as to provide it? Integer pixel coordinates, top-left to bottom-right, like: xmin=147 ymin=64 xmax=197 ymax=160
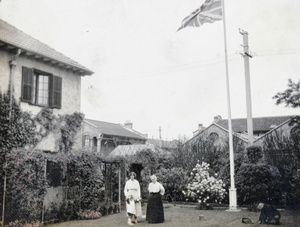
xmin=0 ymin=19 xmax=93 ymax=151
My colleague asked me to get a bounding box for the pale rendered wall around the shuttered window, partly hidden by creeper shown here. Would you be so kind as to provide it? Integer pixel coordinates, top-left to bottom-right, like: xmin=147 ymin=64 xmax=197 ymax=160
xmin=0 ymin=50 xmax=82 ymax=151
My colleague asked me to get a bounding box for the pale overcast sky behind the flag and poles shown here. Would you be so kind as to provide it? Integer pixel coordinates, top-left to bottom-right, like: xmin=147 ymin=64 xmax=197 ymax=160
xmin=0 ymin=0 xmax=300 ymax=140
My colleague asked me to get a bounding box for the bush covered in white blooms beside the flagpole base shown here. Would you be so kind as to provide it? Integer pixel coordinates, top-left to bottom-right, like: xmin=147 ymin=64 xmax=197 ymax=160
xmin=183 ymin=161 xmax=226 ymax=205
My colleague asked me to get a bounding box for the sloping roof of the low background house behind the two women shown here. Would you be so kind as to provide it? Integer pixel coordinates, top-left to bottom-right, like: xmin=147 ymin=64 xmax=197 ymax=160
xmin=84 ymin=119 xmax=147 ymax=140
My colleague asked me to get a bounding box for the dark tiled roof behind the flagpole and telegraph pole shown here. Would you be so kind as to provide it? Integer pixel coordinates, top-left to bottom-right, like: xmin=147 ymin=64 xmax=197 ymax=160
xmin=215 ymin=116 xmax=295 ymax=133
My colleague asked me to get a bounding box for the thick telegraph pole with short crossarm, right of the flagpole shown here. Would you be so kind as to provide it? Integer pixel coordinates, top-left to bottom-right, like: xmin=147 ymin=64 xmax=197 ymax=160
xmin=239 ymin=29 xmax=254 ymax=146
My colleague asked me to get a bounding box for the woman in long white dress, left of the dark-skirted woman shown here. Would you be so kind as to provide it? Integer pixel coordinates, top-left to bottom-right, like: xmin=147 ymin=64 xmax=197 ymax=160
xmin=124 ymin=172 xmax=142 ymax=225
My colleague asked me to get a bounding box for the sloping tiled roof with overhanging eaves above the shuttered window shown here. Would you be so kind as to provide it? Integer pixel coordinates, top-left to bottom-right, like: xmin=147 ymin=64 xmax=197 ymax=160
xmin=0 ymin=19 xmax=93 ymax=75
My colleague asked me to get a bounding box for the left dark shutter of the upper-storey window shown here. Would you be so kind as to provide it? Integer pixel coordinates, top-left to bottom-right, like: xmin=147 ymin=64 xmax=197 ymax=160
xmin=21 ymin=67 xmax=33 ymax=103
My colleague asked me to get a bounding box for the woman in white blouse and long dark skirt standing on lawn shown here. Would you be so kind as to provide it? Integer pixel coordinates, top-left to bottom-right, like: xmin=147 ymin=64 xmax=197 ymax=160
xmin=146 ymin=175 xmax=165 ymax=223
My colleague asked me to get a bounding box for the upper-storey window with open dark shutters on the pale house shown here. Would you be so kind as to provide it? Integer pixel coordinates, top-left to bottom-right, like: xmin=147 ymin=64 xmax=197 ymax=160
xmin=22 ymin=67 xmax=62 ymax=108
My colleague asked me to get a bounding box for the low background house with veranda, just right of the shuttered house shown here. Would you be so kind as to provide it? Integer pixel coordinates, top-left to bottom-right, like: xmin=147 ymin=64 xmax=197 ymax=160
xmin=83 ymin=119 xmax=147 ymax=156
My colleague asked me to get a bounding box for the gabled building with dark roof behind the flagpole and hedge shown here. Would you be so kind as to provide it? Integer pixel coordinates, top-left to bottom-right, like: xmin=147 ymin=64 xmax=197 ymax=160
xmin=187 ymin=115 xmax=299 ymax=146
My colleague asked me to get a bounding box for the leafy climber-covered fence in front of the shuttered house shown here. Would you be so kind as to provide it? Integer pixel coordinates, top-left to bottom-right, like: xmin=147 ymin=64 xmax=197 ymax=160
xmin=5 ymin=149 xmax=104 ymax=222
